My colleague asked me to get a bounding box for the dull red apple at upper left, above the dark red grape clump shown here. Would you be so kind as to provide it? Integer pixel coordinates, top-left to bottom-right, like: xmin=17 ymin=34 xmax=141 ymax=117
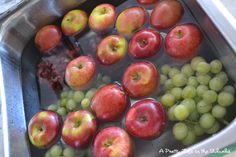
xmin=34 ymin=25 xmax=61 ymax=54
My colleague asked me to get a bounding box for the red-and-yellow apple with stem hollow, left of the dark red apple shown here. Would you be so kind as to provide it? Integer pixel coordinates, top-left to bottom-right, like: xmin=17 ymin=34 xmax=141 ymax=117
xmin=96 ymin=35 xmax=128 ymax=65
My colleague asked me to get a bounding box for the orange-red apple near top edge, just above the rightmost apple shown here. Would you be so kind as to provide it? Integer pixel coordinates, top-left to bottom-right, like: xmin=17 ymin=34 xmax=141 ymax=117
xmin=150 ymin=0 xmax=184 ymax=29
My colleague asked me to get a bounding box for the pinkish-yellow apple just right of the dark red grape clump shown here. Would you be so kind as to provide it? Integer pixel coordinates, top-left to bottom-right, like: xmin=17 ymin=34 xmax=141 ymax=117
xmin=65 ymin=56 xmax=96 ymax=90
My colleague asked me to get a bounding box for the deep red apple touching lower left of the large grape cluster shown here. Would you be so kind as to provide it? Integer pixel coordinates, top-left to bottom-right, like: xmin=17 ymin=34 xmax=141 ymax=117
xmin=125 ymin=99 xmax=166 ymax=140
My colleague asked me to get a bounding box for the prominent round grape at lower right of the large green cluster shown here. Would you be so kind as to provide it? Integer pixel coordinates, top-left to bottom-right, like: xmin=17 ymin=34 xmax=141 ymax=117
xmin=199 ymin=113 xmax=216 ymax=129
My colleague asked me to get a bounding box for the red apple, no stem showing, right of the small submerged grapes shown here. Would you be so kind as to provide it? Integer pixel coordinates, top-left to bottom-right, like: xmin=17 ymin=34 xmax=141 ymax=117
xmin=91 ymin=84 xmax=128 ymax=122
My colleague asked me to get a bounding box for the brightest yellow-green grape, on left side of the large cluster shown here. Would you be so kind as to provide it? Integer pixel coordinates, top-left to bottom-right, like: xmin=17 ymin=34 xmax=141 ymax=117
xmin=174 ymin=104 xmax=190 ymax=121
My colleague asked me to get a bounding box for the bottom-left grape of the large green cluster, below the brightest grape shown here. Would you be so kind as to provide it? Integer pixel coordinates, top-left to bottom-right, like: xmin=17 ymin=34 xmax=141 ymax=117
xmin=172 ymin=122 xmax=188 ymax=140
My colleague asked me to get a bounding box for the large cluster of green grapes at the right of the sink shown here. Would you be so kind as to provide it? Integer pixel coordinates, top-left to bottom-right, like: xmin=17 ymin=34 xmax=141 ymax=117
xmin=160 ymin=57 xmax=235 ymax=145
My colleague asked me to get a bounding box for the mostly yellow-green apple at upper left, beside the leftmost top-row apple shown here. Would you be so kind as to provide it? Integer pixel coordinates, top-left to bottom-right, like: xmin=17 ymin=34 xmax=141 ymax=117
xmin=61 ymin=10 xmax=88 ymax=36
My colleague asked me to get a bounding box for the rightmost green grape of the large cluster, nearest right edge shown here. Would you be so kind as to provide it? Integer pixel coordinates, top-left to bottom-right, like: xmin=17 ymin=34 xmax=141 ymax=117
xmin=217 ymin=92 xmax=234 ymax=107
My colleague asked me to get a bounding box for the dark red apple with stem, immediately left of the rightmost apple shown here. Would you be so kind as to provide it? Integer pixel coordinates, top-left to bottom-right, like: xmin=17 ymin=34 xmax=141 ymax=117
xmin=128 ymin=29 xmax=161 ymax=59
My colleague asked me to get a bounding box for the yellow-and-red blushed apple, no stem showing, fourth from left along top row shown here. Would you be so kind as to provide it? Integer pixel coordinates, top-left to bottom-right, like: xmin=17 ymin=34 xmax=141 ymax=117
xmin=116 ymin=7 xmax=147 ymax=37
